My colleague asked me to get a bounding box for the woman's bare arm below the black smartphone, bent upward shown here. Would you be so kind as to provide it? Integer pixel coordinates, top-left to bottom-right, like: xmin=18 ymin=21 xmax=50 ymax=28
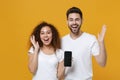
xmin=57 ymin=61 xmax=65 ymax=80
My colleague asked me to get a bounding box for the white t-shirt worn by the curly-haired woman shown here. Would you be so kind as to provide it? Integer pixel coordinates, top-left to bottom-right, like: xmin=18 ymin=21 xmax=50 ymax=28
xmin=29 ymin=47 xmax=64 ymax=80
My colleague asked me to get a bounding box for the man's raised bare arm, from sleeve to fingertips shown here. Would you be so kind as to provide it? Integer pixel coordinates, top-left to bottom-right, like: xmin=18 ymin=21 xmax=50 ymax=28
xmin=95 ymin=25 xmax=107 ymax=67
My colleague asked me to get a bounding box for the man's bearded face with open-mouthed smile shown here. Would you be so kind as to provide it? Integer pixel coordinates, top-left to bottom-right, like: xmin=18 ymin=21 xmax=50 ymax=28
xmin=67 ymin=13 xmax=82 ymax=34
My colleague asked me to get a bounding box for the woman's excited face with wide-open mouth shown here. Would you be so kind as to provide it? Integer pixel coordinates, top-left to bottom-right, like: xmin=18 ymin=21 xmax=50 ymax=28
xmin=40 ymin=26 xmax=52 ymax=46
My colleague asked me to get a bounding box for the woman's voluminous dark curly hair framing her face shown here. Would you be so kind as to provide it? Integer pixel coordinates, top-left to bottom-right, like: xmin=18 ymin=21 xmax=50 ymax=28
xmin=30 ymin=22 xmax=60 ymax=50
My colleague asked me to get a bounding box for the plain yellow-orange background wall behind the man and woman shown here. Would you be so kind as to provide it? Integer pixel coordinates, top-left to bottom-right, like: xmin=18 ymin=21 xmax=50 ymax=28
xmin=0 ymin=0 xmax=120 ymax=80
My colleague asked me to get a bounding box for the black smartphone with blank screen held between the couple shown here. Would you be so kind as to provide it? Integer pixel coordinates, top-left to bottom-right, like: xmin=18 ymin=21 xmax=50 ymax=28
xmin=64 ymin=51 xmax=72 ymax=67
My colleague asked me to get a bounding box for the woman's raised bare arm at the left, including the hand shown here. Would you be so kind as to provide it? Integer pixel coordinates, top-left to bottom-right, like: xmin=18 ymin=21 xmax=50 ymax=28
xmin=28 ymin=36 xmax=39 ymax=74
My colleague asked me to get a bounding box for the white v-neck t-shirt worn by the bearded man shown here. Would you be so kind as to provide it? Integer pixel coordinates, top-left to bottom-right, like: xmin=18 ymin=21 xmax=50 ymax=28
xmin=62 ymin=32 xmax=99 ymax=80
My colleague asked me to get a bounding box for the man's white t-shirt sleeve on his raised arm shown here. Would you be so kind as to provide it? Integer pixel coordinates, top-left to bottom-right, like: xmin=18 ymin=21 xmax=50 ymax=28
xmin=91 ymin=36 xmax=100 ymax=56
